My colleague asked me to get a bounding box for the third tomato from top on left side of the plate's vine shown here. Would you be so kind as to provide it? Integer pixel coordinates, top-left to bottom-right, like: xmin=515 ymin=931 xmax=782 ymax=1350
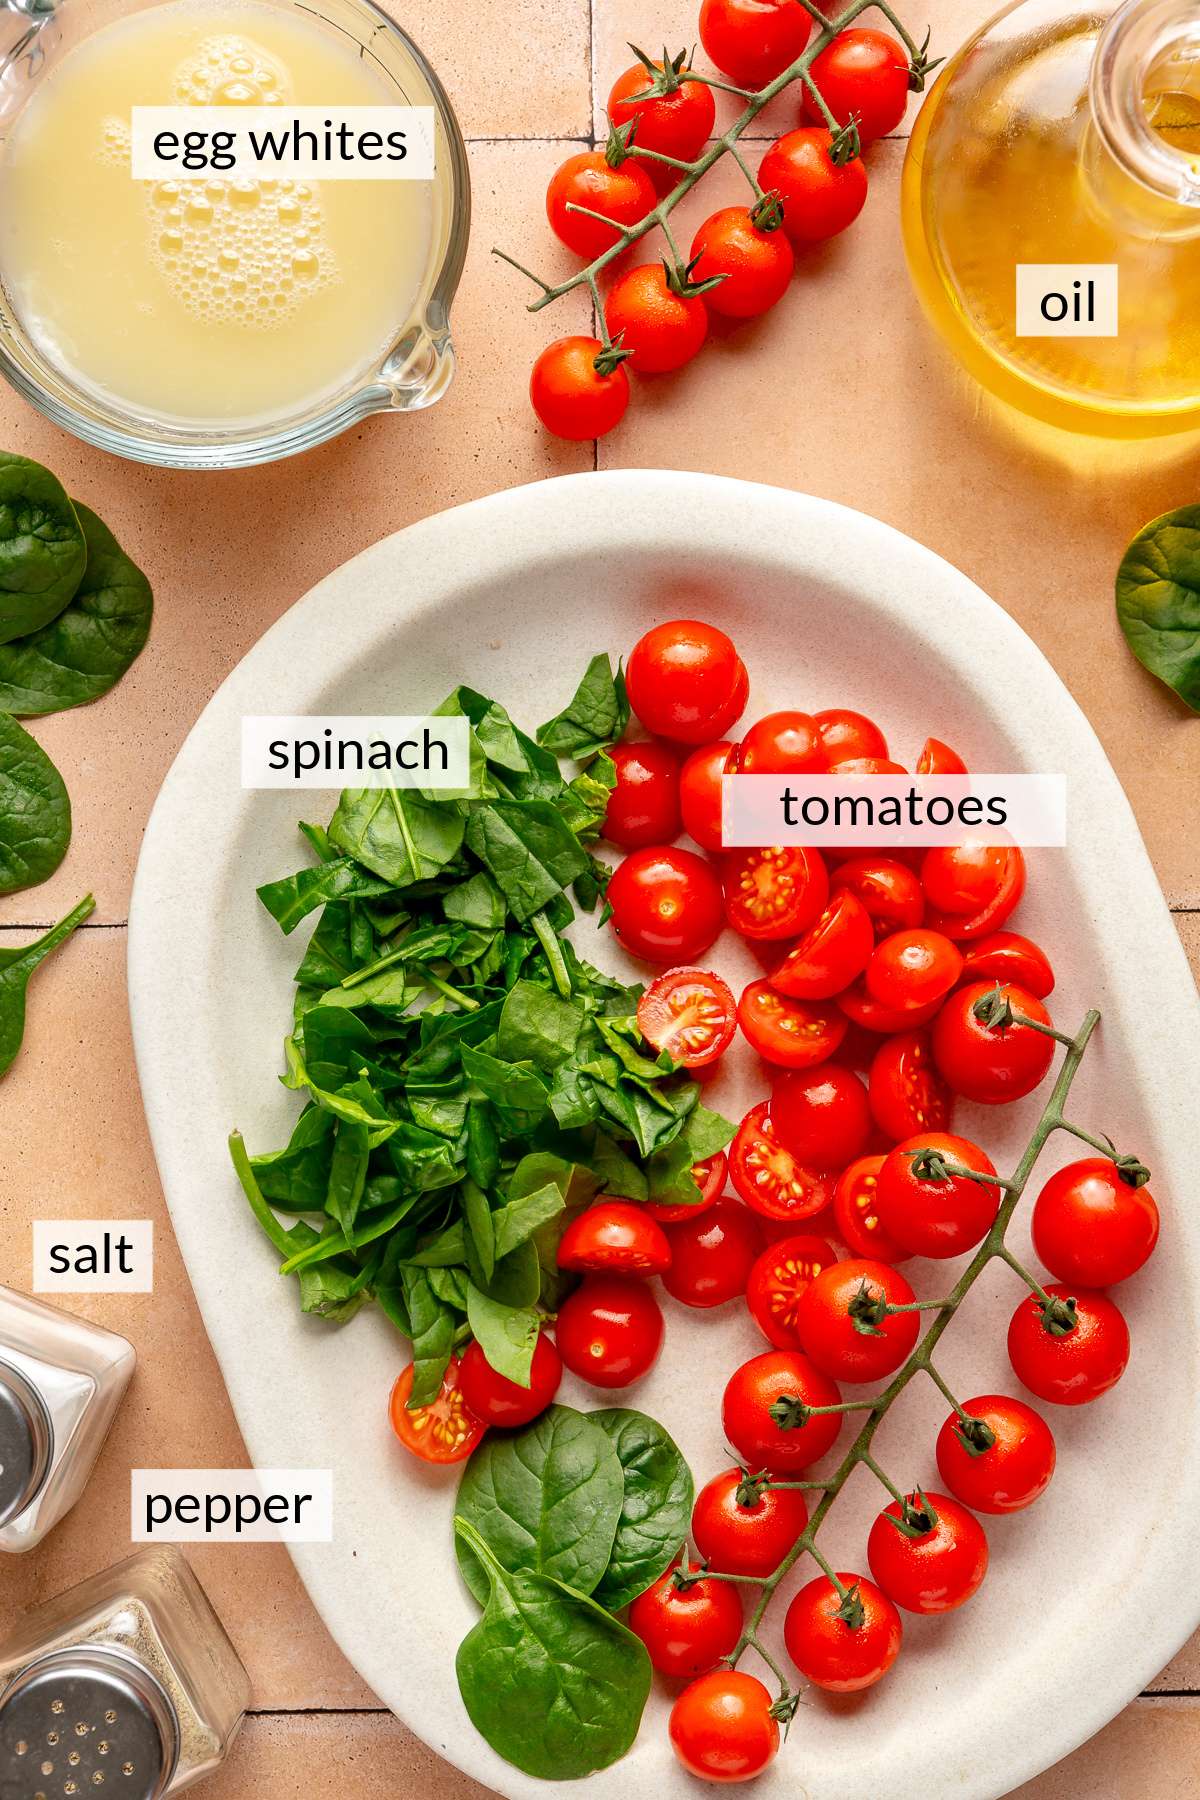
xmin=797 ymin=1256 xmax=921 ymax=1382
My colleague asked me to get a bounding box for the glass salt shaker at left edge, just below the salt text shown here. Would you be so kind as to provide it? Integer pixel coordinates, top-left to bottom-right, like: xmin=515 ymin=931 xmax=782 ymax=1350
xmin=0 ymin=1287 xmax=135 ymax=1555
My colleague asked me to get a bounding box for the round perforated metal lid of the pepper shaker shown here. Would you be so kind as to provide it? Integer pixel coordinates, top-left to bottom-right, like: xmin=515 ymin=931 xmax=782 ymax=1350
xmin=0 ymin=1647 xmax=178 ymax=1800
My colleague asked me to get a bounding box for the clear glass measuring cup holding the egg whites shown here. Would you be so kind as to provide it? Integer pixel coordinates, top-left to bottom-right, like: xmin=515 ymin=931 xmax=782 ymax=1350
xmin=0 ymin=0 xmax=470 ymax=468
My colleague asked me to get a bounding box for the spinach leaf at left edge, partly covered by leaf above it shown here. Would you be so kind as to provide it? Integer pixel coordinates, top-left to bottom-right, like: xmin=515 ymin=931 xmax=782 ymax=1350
xmin=0 ymin=500 xmax=155 ymax=718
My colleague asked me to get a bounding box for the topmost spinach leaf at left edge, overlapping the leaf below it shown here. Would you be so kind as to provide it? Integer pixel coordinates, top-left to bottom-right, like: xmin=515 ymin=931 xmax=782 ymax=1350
xmin=0 ymin=450 xmax=88 ymax=644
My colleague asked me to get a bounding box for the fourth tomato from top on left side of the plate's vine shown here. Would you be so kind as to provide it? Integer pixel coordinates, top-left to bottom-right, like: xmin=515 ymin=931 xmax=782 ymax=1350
xmin=721 ymin=1346 xmax=844 ymax=1476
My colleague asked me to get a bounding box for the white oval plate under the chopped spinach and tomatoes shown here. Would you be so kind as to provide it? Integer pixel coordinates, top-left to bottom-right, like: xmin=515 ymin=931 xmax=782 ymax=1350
xmin=130 ymin=472 xmax=1200 ymax=1800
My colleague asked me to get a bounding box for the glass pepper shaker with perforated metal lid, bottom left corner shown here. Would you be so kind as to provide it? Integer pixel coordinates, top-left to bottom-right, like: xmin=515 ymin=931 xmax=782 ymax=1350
xmin=0 ymin=1544 xmax=250 ymax=1800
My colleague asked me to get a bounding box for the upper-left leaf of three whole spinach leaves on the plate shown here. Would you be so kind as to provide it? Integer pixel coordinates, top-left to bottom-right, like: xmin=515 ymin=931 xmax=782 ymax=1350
xmin=455 ymin=1406 xmax=624 ymax=1606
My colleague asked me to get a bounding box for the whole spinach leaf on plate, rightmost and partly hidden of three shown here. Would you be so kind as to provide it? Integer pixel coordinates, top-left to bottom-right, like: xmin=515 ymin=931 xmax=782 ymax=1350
xmin=588 ymin=1406 xmax=694 ymax=1613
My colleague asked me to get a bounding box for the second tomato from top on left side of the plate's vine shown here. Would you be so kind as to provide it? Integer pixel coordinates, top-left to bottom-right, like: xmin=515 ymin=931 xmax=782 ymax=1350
xmin=878 ymin=1130 xmax=1002 ymax=1256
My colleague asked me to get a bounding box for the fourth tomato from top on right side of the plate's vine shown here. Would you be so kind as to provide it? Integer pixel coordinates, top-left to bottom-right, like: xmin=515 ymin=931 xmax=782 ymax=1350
xmin=867 ymin=1494 xmax=988 ymax=1615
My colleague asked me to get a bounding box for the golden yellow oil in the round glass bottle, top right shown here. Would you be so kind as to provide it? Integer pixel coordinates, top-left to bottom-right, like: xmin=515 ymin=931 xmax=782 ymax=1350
xmin=901 ymin=5 xmax=1200 ymax=437
